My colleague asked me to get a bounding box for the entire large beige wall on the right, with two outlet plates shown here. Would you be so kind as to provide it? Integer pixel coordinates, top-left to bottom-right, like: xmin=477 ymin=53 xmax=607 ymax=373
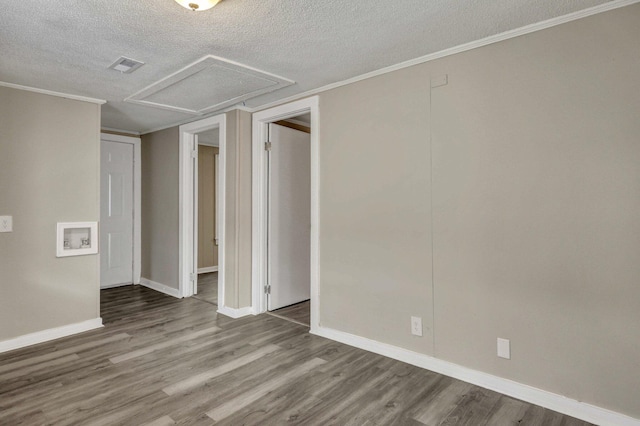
xmin=320 ymin=5 xmax=640 ymax=417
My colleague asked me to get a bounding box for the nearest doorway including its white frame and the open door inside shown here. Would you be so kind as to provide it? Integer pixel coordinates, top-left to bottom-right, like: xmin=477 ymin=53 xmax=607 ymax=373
xmin=252 ymin=97 xmax=320 ymax=333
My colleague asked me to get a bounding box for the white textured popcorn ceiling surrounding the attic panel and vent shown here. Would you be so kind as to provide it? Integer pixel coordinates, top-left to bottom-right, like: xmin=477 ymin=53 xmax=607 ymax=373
xmin=0 ymin=0 xmax=608 ymax=132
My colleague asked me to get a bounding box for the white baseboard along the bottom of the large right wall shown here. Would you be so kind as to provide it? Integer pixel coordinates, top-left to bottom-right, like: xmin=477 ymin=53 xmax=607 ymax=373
xmin=310 ymin=327 xmax=640 ymax=426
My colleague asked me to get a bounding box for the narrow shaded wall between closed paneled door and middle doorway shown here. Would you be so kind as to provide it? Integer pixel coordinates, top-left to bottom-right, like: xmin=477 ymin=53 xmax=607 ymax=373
xmin=141 ymin=127 xmax=180 ymax=289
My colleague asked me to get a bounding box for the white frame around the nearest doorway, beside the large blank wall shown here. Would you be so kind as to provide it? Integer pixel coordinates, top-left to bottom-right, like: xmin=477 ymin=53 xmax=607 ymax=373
xmin=251 ymin=96 xmax=320 ymax=333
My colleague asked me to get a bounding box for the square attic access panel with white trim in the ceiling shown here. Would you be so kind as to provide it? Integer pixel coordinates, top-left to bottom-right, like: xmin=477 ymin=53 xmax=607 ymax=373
xmin=125 ymin=55 xmax=295 ymax=115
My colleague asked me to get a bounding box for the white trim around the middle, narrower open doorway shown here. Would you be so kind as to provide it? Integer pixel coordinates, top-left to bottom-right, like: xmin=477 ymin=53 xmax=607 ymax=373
xmin=178 ymin=114 xmax=227 ymax=309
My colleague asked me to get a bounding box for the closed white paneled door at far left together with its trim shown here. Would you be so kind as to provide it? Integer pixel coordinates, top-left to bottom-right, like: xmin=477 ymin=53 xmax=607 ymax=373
xmin=99 ymin=133 xmax=141 ymax=289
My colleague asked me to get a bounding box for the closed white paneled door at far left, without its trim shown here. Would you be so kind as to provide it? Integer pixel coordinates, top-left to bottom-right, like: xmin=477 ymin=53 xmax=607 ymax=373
xmin=100 ymin=141 xmax=133 ymax=287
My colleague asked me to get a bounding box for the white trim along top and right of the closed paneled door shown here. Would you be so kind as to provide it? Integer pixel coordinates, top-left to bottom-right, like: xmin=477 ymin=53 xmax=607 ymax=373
xmin=100 ymin=133 xmax=142 ymax=284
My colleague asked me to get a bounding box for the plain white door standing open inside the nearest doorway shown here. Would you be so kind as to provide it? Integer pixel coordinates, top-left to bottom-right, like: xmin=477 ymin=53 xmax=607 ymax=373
xmin=267 ymin=124 xmax=311 ymax=311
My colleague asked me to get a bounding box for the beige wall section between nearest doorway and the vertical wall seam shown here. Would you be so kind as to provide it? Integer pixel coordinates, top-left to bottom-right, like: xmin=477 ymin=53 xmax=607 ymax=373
xmin=320 ymin=67 xmax=433 ymax=354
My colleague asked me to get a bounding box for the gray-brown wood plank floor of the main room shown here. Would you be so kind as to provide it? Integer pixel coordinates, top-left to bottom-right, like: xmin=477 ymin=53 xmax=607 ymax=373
xmin=0 ymin=286 xmax=586 ymax=426
